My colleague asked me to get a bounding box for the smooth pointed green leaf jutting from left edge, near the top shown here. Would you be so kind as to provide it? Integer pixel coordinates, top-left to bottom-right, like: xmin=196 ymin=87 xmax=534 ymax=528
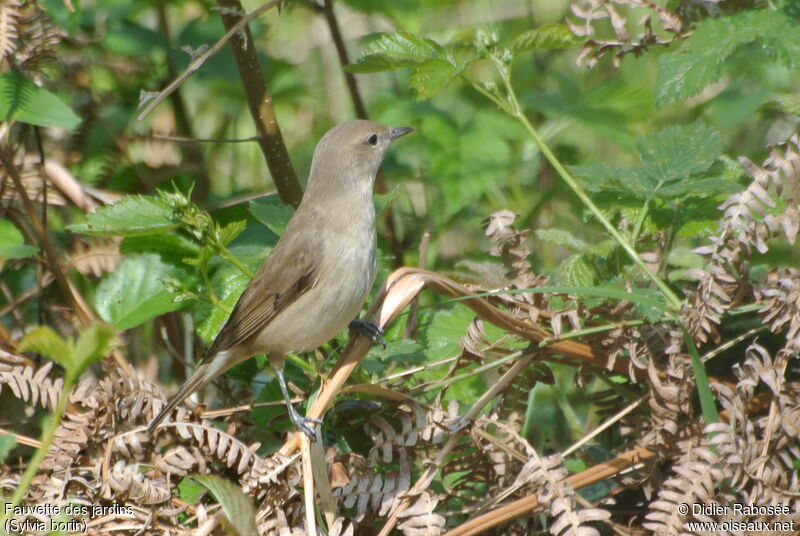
xmin=0 ymin=71 xmax=81 ymax=130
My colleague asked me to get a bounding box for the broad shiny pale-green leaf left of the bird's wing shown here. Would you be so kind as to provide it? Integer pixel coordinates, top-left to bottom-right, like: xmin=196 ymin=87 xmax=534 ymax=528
xmin=95 ymin=254 xmax=183 ymax=330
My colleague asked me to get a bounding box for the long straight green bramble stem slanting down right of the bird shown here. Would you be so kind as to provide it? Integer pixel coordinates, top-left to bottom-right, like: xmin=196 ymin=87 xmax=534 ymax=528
xmin=468 ymin=55 xmax=681 ymax=310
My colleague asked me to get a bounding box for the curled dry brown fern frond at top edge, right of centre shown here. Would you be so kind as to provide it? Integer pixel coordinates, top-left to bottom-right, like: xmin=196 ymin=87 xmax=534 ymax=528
xmin=567 ymin=0 xmax=688 ymax=68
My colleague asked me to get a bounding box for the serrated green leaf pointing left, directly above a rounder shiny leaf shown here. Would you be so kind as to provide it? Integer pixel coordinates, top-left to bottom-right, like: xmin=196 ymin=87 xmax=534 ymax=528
xmin=67 ymin=195 xmax=179 ymax=236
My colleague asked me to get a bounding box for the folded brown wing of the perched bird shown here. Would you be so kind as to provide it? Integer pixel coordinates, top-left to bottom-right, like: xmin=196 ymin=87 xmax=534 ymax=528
xmin=204 ymin=230 xmax=324 ymax=361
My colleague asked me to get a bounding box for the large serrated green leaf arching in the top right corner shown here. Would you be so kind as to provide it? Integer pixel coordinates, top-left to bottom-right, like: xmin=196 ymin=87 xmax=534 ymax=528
xmin=656 ymin=9 xmax=800 ymax=106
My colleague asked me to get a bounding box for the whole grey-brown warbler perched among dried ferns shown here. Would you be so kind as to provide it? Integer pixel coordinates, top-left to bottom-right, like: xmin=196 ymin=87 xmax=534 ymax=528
xmin=147 ymin=120 xmax=412 ymax=439
